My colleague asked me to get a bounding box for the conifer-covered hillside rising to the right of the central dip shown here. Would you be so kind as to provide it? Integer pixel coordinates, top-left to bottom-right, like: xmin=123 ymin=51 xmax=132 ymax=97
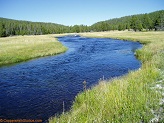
xmin=91 ymin=10 xmax=164 ymax=31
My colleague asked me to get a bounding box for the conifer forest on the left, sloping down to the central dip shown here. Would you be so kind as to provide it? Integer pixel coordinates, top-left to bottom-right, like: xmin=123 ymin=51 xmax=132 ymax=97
xmin=0 ymin=18 xmax=89 ymax=37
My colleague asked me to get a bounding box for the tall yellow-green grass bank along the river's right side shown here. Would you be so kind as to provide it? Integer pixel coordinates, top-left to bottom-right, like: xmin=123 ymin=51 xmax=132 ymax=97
xmin=49 ymin=31 xmax=164 ymax=123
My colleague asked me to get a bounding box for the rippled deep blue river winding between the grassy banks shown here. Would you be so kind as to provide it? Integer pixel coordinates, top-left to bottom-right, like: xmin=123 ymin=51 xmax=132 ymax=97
xmin=0 ymin=36 xmax=141 ymax=121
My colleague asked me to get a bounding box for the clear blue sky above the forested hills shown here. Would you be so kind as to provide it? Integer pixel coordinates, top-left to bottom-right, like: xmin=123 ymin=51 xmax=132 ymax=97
xmin=0 ymin=0 xmax=164 ymax=26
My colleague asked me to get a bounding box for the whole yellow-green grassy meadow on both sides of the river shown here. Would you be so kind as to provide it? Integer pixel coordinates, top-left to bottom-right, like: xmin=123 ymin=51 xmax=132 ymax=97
xmin=0 ymin=31 xmax=164 ymax=123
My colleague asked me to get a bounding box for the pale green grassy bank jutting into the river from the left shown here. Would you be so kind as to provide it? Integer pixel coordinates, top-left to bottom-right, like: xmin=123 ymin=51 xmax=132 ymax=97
xmin=0 ymin=35 xmax=67 ymax=66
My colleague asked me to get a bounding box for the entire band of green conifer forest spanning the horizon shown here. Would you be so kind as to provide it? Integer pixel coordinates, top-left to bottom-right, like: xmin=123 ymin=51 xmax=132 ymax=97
xmin=0 ymin=10 xmax=164 ymax=37
